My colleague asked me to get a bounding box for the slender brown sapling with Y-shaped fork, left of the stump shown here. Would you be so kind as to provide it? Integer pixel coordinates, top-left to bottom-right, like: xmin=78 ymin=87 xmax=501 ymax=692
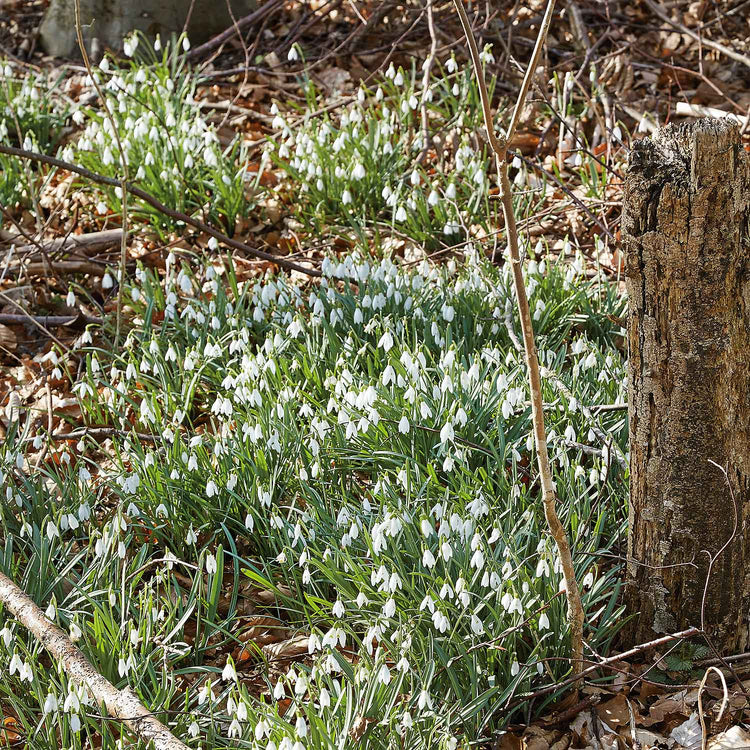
xmin=453 ymin=0 xmax=583 ymax=675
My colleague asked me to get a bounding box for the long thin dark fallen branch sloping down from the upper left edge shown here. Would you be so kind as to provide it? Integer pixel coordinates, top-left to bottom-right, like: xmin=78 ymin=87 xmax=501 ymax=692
xmin=0 ymin=143 xmax=322 ymax=277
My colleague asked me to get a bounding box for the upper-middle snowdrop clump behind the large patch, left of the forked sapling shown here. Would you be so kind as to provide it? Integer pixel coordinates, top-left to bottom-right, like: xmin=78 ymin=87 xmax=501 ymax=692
xmin=270 ymin=58 xmax=512 ymax=250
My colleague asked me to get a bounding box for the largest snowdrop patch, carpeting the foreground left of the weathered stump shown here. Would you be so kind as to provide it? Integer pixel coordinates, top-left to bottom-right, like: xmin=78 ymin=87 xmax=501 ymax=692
xmin=0 ymin=244 xmax=626 ymax=750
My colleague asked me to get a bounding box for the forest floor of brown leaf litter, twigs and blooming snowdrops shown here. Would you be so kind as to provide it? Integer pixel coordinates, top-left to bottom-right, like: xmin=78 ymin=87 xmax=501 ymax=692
xmin=0 ymin=0 xmax=750 ymax=750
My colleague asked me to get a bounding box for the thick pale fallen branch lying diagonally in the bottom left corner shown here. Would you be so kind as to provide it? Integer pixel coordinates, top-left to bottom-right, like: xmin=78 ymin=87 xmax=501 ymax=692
xmin=0 ymin=573 xmax=188 ymax=750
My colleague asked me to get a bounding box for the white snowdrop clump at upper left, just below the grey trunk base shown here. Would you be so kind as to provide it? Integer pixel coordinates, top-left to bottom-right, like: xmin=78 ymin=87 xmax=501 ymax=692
xmin=63 ymin=37 xmax=252 ymax=234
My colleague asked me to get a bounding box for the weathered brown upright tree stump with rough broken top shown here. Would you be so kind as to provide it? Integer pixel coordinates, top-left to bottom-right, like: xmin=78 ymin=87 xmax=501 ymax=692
xmin=622 ymin=119 xmax=750 ymax=653
